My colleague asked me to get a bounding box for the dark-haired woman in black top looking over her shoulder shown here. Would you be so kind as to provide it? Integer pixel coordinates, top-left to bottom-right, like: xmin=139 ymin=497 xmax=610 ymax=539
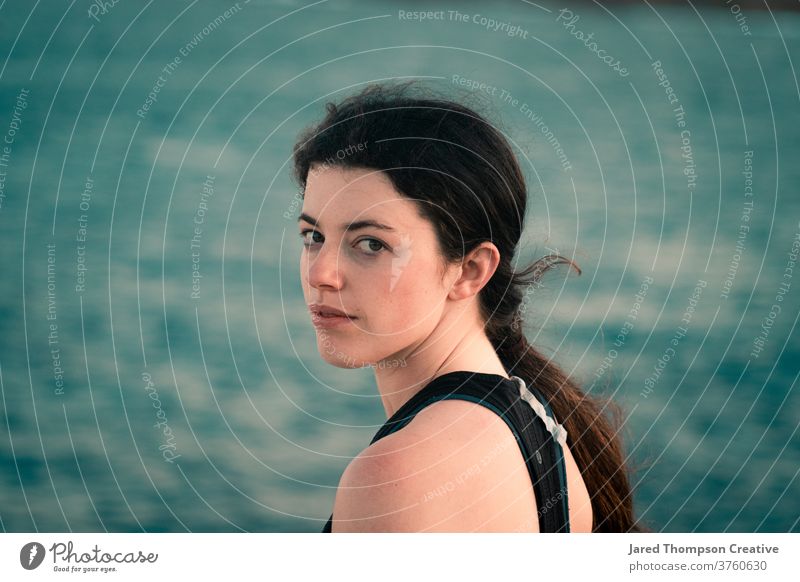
xmin=294 ymin=82 xmax=642 ymax=532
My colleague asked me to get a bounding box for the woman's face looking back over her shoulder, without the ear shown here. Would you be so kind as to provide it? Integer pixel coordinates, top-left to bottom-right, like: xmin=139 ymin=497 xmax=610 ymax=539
xmin=298 ymin=165 xmax=457 ymax=368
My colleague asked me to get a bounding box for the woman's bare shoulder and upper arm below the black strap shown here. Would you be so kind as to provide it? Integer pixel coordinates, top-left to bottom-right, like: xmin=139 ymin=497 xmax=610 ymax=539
xmin=333 ymin=399 xmax=538 ymax=532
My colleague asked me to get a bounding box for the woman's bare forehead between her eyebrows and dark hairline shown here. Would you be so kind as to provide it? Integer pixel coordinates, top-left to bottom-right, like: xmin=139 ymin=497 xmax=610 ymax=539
xmin=303 ymin=166 xmax=423 ymax=229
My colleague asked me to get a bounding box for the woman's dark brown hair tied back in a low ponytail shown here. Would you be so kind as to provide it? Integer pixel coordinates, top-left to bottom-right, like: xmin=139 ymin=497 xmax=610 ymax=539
xmin=294 ymin=81 xmax=649 ymax=532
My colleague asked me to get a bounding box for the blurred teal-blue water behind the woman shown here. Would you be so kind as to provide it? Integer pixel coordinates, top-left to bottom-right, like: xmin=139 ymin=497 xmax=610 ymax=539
xmin=0 ymin=0 xmax=800 ymax=532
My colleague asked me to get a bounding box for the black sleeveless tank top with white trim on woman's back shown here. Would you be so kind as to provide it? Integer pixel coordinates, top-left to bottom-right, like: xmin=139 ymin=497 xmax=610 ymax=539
xmin=322 ymin=371 xmax=570 ymax=533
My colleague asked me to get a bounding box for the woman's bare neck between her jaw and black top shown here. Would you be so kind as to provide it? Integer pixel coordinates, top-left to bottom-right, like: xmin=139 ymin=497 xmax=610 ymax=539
xmin=375 ymin=317 xmax=508 ymax=418
